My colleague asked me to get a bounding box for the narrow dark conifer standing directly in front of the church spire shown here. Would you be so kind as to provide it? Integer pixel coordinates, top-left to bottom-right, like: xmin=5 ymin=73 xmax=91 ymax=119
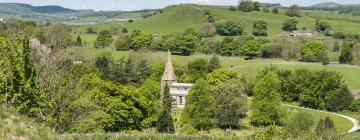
xmin=156 ymin=84 xmax=175 ymax=133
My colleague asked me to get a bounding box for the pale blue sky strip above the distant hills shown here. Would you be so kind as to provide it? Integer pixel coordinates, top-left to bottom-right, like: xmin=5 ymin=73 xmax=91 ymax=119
xmin=0 ymin=0 xmax=360 ymax=10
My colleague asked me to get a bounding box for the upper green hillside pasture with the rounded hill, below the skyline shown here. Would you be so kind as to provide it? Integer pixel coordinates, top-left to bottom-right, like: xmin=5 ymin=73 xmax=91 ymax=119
xmin=73 ymin=5 xmax=360 ymax=36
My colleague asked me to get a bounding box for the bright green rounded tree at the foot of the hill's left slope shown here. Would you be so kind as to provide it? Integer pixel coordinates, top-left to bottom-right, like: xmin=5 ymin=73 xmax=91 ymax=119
xmin=130 ymin=30 xmax=154 ymax=50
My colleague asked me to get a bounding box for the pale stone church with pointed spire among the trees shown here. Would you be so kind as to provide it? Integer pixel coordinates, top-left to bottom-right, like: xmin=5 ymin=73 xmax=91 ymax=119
xmin=161 ymin=51 xmax=193 ymax=108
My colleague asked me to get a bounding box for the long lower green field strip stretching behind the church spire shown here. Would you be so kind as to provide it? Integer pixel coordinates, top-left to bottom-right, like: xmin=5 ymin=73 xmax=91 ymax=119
xmin=76 ymin=47 xmax=360 ymax=90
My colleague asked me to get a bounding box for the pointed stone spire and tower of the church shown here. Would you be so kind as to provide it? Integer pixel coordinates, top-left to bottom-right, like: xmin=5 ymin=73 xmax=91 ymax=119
xmin=161 ymin=50 xmax=176 ymax=96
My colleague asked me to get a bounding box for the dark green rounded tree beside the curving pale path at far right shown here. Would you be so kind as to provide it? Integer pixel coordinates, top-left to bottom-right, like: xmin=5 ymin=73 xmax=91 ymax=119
xmin=326 ymin=86 xmax=354 ymax=112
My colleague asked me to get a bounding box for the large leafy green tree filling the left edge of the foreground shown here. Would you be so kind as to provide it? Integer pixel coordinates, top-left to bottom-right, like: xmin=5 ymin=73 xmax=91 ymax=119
xmin=0 ymin=36 xmax=43 ymax=117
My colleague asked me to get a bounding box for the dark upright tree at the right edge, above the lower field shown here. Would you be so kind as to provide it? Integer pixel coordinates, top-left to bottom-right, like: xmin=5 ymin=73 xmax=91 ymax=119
xmin=339 ymin=41 xmax=355 ymax=64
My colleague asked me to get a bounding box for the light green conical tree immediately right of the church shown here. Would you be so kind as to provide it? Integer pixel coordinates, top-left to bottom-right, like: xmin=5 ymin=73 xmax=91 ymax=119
xmin=181 ymin=79 xmax=216 ymax=130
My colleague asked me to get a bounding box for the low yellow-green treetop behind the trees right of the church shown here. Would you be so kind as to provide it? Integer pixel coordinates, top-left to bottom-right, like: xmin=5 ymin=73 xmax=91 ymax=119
xmin=206 ymin=69 xmax=239 ymax=86
